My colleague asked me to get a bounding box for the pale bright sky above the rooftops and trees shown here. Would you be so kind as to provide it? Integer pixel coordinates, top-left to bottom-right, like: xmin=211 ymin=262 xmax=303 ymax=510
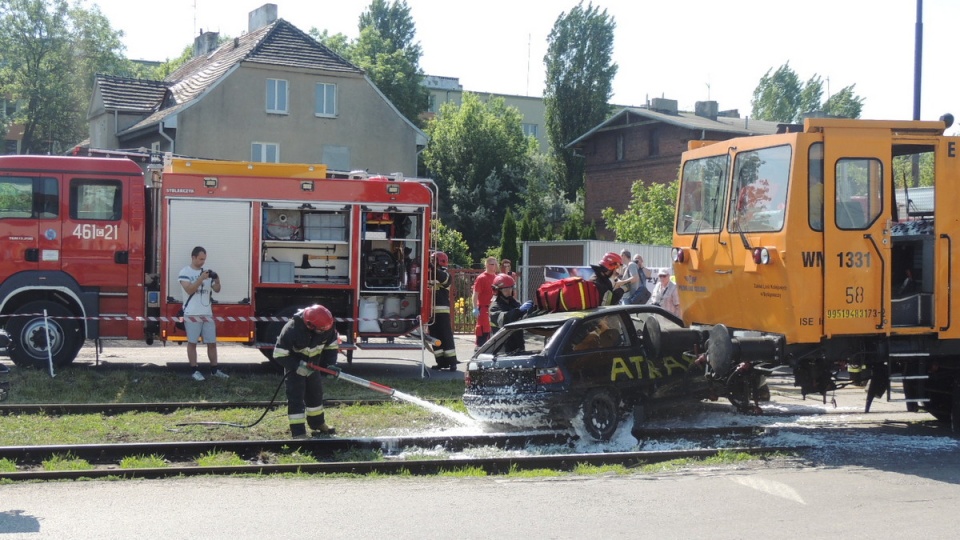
xmin=86 ymin=0 xmax=960 ymax=120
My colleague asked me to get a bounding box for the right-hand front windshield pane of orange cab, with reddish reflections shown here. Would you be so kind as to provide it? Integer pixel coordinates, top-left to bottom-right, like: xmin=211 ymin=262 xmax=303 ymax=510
xmin=728 ymin=146 xmax=793 ymax=232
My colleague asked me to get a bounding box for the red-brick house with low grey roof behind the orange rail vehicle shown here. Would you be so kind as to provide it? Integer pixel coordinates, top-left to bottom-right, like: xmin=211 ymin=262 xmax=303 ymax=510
xmin=567 ymin=98 xmax=778 ymax=240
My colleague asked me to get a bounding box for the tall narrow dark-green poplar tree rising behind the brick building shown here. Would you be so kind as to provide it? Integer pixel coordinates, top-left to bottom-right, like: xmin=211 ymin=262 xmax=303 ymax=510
xmin=543 ymin=2 xmax=617 ymax=200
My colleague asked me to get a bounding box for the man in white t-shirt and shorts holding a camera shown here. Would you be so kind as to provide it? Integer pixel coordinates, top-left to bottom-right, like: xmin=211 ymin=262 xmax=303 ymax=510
xmin=178 ymin=246 xmax=229 ymax=381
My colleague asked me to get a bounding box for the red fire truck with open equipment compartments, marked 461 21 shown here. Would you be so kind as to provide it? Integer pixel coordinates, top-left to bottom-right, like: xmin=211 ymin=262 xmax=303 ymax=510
xmin=0 ymin=155 xmax=436 ymax=366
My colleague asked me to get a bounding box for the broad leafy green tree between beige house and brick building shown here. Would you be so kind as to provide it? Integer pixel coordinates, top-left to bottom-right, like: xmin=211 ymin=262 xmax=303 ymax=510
xmin=423 ymin=92 xmax=535 ymax=257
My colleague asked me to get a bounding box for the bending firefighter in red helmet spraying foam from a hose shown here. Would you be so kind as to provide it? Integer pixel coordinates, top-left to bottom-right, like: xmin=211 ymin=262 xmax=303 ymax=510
xmin=273 ymin=304 xmax=339 ymax=439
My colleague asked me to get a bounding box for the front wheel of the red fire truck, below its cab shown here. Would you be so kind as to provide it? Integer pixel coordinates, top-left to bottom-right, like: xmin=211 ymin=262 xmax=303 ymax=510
xmin=6 ymin=301 xmax=83 ymax=369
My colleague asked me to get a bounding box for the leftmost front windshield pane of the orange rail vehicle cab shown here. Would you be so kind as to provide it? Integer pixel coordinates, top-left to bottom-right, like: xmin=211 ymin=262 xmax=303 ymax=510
xmin=677 ymin=154 xmax=730 ymax=234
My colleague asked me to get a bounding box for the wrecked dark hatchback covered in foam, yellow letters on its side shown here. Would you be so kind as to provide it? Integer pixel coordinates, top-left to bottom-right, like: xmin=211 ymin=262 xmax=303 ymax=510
xmin=463 ymin=305 xmax=765 ymax=440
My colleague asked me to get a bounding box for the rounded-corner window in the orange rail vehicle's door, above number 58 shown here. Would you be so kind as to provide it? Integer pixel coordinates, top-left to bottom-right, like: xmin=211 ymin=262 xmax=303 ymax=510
xmin=834 ymin=158 xmax=883 ymax=230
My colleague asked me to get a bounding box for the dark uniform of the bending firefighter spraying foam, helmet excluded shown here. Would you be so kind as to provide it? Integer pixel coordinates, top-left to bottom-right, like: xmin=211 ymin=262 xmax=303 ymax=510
xmin=273 ymin=313 xmax=339 ymax=437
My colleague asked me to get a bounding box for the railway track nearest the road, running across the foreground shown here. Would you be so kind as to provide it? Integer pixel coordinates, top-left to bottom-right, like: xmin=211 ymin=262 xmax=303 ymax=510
xmin=0 ymin=431 xmax=804 ymax=481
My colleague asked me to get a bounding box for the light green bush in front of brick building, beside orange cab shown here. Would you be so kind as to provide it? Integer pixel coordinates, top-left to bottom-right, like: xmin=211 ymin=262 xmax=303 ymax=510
xmin=602 ymin=180 xmax=680 ymax=246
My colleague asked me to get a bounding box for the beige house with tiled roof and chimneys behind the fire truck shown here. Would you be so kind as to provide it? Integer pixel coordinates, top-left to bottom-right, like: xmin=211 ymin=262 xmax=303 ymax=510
xmin=88 ymin=4 xmax=427 ymax=176
